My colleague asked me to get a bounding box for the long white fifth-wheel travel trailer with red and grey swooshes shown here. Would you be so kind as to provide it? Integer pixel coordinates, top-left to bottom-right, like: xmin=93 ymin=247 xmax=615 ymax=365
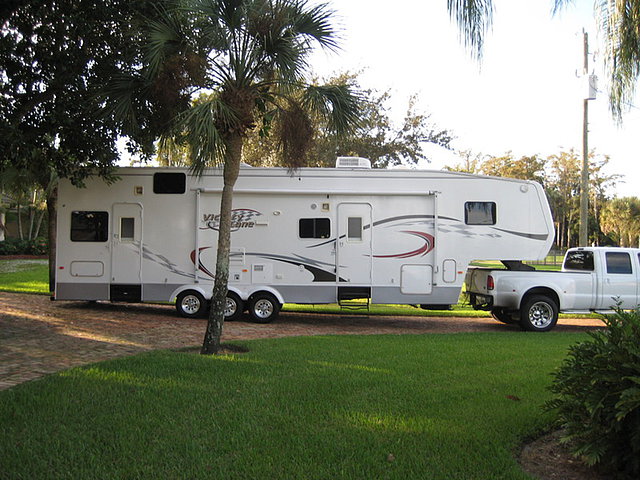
xmin=54 ymin=157 xmax=554 ymax=322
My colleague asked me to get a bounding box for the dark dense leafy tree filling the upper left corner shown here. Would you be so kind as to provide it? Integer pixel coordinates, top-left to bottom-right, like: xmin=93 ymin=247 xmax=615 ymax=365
xmin=0 ymin=0 xmax=160 ymax=285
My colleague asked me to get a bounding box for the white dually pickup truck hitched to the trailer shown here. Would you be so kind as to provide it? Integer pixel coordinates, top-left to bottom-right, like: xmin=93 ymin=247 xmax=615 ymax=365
xmin=465 ymin=247 xmax=640 ymax=332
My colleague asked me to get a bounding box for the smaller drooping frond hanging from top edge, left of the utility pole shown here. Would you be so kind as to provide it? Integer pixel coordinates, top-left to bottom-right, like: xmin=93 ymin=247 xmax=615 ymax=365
xmin=447 ymin=0 xmax=494 ymax=59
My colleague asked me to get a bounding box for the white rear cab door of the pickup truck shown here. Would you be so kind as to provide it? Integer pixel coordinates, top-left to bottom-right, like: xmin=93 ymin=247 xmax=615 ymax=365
xmin=600 ymin=252 xmax=638 ymax=310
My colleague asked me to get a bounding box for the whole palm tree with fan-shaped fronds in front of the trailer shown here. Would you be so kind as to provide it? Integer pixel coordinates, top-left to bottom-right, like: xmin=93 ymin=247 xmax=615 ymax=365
xmin=116 ymin=0 xmax=359 ymax=354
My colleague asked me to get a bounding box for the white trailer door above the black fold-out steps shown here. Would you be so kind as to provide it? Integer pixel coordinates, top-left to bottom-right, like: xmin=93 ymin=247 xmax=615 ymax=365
xmin=336 ymin=203 xmax=371 ymax=286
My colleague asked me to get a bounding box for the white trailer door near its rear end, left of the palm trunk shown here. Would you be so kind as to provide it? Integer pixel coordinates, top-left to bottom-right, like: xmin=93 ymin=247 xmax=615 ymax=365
xmin=111 ymin=203 xmax=142 ymax=301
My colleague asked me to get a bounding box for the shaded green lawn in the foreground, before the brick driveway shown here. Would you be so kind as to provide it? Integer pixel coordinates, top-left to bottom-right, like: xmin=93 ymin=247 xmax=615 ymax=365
xmin=0 ymin=332 xmax=585 ymax=480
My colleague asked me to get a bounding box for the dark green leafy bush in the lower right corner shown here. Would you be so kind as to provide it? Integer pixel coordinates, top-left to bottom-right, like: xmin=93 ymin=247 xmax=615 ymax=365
xmin=546 ymin=310 xmax=640 ymax=479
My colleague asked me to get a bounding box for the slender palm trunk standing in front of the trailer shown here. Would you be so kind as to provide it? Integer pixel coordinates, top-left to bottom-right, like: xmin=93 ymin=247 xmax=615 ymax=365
xmin=200 ymin=133 xmax=243 ymax=355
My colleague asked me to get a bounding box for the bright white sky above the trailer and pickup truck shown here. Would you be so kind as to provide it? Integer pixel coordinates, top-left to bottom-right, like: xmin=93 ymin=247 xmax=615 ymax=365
xmin=312 ymin=0 xmax=640 ymax=196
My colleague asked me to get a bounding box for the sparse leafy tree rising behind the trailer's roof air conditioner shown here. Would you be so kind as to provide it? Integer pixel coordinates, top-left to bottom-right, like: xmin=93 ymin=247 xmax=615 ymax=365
xmin=244 ymin=73 xmax=453 ymax=168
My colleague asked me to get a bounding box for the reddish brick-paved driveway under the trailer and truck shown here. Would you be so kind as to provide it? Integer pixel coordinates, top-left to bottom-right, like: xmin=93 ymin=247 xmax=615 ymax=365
xmin=0 ymin=292 xmax=602 ymax=390
